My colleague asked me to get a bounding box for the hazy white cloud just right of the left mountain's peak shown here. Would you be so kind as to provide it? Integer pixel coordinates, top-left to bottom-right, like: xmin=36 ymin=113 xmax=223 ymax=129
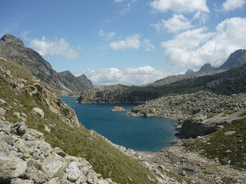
xmin=22 ymin=35 xmax=78 ymax=59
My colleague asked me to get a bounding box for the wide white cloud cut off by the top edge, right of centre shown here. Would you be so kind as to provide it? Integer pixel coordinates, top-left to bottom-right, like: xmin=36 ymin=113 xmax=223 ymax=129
xmin=150 ymin=0 xmax=209 ymax=13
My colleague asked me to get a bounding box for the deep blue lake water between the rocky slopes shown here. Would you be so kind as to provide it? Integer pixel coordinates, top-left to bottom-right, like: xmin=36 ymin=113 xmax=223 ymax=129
xmin=61 ymin=96 xmax=178 ymax=152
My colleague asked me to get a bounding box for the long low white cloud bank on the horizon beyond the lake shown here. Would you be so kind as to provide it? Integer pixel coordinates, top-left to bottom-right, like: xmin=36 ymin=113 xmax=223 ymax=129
xmin=76 ymin=66 xmax=168 ymax=85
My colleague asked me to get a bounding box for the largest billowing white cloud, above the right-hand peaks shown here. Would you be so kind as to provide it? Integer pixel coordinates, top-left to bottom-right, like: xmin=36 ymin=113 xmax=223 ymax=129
xmin=161 ymin=17 xmax=246 ymax=72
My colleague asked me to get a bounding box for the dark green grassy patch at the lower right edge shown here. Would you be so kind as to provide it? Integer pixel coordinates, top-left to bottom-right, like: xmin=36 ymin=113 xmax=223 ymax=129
xmin=186 ymin=118 xmax=246 ymax=169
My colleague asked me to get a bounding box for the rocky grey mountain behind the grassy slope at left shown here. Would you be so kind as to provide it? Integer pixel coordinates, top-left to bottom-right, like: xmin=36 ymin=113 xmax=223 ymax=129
xmin=0 ymin=34 xmax=92 ymax=95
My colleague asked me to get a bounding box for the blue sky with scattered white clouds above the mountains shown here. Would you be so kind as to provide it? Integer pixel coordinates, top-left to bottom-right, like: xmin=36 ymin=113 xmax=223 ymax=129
xmin=0 ymin=0 xmax=246 ymax=85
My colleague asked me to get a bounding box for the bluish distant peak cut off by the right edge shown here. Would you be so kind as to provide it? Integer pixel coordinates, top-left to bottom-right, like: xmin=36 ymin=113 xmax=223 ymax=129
xmin=219 ymin=49 xmax=246 ymax=70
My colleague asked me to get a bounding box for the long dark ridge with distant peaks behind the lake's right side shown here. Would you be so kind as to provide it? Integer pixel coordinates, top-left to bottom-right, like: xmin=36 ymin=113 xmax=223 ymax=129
xmin=78 ymin=50 xmax=246 ymax=103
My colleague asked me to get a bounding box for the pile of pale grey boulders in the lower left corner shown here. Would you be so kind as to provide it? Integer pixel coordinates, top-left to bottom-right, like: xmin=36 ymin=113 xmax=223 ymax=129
xmin=0 ymin=120 xmax=115 ymax=184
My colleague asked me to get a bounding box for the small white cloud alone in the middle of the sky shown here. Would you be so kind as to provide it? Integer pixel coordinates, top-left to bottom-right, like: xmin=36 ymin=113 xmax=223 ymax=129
xmin=109 ymin=34 xmax=141 ymax=50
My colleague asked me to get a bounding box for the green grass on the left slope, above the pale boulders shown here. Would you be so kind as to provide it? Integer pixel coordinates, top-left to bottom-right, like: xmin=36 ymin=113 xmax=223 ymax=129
xmin=0 ymin=56 xmax=157 ymax=184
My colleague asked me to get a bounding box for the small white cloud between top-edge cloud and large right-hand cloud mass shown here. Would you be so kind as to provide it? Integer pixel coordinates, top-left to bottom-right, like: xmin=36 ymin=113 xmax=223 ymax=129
xmin=152 ymin=14 xmax=192 ymax=33
